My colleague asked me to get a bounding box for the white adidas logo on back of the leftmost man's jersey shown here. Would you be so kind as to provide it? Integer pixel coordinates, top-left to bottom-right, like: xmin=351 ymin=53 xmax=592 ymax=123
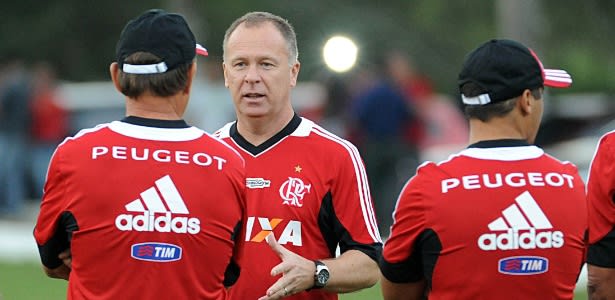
xmin=115 ymin=175 xmax=201 ymax=234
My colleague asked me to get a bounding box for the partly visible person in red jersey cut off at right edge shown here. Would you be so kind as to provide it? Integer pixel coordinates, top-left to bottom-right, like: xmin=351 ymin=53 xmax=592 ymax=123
xmin=587 ymin=127 xmax=615 ymax=300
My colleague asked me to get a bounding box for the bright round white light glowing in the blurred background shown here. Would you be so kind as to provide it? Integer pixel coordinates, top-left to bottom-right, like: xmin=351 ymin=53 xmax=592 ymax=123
xmin=322 ymin=36 xmax=358 ymax=73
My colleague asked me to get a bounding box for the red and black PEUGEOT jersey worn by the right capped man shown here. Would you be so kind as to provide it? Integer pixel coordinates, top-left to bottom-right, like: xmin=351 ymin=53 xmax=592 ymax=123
xmin=380 ymin=140 xmax=587 ymax=299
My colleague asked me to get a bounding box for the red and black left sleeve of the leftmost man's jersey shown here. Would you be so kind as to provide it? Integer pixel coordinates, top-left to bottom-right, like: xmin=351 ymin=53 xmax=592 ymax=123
xmin=34 ymin=146 xmax=68 ymax=269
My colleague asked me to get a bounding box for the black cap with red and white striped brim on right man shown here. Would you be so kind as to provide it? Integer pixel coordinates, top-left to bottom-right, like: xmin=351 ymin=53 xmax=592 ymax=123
xmin=458 ymin=39 xmax=572 ymax=105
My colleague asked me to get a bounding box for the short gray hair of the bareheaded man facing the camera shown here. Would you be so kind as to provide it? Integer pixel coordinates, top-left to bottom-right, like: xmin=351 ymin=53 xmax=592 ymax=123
xmin=222 ymin=11 xmax=299 ymax=65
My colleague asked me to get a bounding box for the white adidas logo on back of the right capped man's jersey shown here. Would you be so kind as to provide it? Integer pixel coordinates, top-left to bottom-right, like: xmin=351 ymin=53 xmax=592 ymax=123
xmin=478 ymin=191 xmax=564 ymax=251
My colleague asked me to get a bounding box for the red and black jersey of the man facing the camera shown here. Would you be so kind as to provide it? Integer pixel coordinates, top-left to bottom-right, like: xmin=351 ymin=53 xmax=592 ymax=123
xmin=215 ymin=115 xmax=381 ymax=299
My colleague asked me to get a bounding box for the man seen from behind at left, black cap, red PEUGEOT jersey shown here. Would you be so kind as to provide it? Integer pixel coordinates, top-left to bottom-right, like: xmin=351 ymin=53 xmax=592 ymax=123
xmin=34 ymin=10 xmax=245 ymax=299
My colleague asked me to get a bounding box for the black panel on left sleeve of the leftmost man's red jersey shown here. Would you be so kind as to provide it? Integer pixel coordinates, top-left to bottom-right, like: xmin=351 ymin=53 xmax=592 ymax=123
xmin=38 ymin=211 xmax=79 ymax=269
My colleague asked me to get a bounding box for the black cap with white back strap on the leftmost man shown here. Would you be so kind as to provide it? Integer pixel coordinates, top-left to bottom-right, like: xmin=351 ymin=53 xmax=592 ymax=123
xmin=116 ymin=9 xmax=207 ymax=74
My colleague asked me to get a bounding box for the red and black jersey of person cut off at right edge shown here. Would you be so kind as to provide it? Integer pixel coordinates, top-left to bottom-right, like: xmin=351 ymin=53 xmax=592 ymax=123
xmin=587 ymin=132 xmax=615 ymax=268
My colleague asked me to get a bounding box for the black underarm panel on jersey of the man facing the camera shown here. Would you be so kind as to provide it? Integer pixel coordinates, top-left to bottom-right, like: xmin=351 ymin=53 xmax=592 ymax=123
xmin=318 ymin=192 xmax=382 ymax=262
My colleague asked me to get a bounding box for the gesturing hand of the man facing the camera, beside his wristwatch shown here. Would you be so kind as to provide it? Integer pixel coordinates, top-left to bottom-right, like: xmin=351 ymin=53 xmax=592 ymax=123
xmin=259 ymin=234 xmax=316 ymax=300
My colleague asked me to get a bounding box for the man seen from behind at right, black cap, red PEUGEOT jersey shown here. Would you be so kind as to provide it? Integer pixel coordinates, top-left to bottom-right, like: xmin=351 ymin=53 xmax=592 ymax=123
xmin=380 ymin=39 xmax=587 ymax=299
